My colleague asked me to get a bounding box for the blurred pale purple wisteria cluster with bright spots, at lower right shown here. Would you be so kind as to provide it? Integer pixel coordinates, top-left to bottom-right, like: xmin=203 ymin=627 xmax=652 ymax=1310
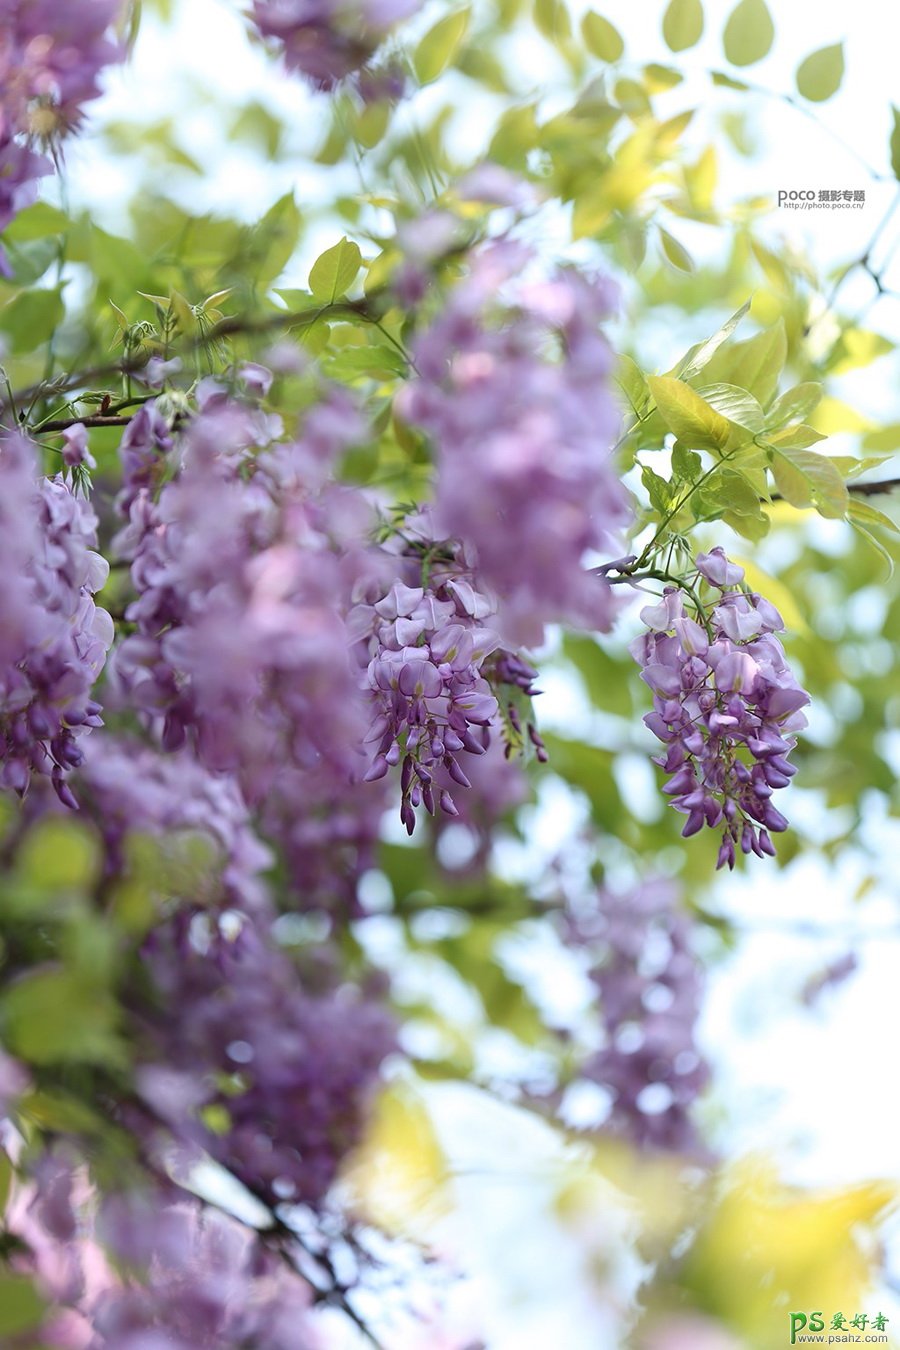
xmin=568 ymin=880 xmax=710 ymax=1153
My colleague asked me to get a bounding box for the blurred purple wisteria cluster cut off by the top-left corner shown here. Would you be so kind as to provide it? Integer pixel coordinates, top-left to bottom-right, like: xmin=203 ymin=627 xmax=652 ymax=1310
xmin=0 ymin=0 xmax=121 ymax=275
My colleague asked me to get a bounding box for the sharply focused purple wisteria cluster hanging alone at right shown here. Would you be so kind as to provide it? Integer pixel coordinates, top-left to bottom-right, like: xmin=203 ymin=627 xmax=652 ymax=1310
xmin=630 ymin=548 xmax=810 ymax=868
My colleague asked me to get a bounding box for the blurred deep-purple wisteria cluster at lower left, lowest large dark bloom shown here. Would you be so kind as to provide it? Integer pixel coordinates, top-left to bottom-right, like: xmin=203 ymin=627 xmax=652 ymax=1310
xmin=139 ymin=911 xmax=395 ymax=1206
